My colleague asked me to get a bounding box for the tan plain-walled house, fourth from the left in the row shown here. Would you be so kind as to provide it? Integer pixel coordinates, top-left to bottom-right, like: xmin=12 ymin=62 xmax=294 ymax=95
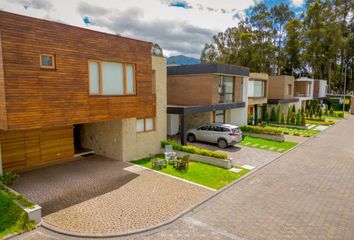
xmin=268 ymin=75 xmax=299 ymax=114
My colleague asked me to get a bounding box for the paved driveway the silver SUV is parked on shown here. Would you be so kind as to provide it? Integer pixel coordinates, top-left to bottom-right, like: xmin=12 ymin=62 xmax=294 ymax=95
xmin=193 ymin=142 xmax=280 ymax=168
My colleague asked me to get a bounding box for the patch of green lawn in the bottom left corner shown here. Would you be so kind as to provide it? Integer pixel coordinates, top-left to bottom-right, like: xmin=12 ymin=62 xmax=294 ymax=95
xmin=0 ymin=190 xmax=35 ymax=239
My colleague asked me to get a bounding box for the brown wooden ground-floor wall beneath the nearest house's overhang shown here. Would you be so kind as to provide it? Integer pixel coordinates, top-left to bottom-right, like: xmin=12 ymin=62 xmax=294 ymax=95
xmin=0 ymin=126 xmax=74 ymax=172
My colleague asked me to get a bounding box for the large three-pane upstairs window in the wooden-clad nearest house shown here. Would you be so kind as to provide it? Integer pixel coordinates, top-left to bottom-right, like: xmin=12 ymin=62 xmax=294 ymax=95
xmin=89 ymin=61 xmax=136 ymax=96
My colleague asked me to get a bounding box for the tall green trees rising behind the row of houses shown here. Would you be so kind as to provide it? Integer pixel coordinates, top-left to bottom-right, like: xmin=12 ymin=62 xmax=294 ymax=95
xmin=201 ymin=0 xmax=354 ymax=91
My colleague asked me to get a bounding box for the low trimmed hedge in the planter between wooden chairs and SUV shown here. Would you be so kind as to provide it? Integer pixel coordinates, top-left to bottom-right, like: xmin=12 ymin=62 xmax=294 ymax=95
xmin=161 ymin=140 xmax=227 ymax=159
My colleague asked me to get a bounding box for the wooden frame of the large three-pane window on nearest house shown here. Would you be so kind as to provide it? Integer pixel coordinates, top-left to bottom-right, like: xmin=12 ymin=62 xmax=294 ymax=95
xmin=87 ymin=59 xmax=137 ymax=97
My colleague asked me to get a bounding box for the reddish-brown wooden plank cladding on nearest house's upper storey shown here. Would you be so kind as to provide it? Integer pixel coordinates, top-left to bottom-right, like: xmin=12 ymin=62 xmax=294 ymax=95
xmin=0 ymin=11 xmax=156 ymax=130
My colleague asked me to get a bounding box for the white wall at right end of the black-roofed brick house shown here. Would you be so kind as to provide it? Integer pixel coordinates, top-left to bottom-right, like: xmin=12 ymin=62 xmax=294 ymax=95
xmin=230 ymin=77 xmax=249 ymax=126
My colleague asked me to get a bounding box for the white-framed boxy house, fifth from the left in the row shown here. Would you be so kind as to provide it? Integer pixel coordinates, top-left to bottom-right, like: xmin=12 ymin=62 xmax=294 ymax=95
xmin=294 ymin=77 xmax=314 ymax=108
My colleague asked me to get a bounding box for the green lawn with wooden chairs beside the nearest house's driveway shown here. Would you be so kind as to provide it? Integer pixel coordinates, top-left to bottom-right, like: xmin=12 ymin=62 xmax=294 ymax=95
xmin=132 ymin=158 xmax=249 ymax=189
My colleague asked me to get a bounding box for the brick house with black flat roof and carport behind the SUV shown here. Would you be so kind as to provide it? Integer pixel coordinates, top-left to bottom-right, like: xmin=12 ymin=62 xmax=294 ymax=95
xmin=167 ymin=64 xmax=249 ymax=144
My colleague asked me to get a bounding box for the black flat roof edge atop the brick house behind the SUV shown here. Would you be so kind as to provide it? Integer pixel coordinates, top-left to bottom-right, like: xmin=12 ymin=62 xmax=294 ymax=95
xmin=167 ymin=63 xmax=250 ymax=76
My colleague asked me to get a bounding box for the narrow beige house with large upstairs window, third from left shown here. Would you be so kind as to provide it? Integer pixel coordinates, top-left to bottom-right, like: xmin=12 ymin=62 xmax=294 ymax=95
xmin=248 ymin=73 xmax=269 ymax=124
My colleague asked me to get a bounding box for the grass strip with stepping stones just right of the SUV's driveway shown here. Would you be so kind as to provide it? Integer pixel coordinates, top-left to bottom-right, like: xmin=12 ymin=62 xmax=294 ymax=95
xmin=240 ymin=136 xmax=297 ymax=152
